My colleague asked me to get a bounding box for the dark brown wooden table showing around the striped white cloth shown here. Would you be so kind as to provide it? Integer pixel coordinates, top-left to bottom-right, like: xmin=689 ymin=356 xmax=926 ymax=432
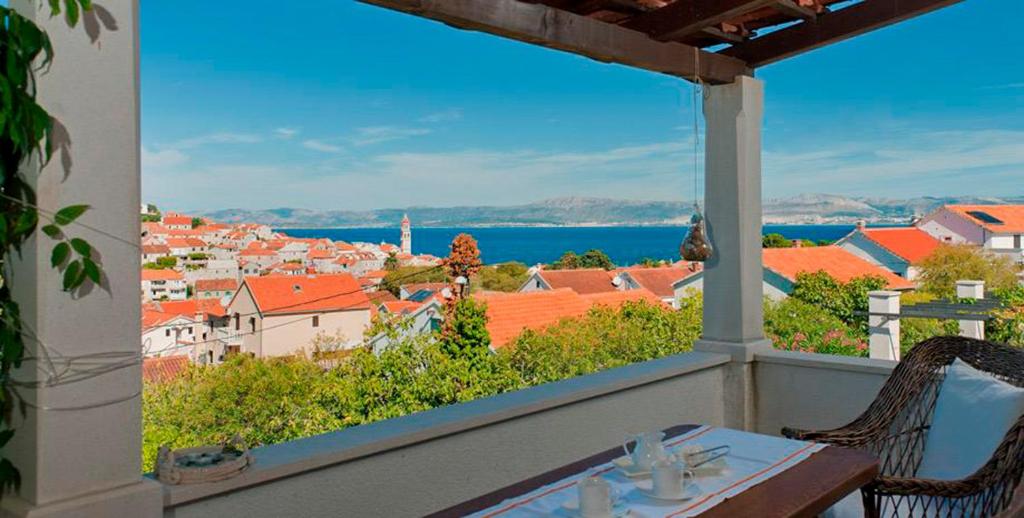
xmin=430 ymin=425 xmax=879 ymax=518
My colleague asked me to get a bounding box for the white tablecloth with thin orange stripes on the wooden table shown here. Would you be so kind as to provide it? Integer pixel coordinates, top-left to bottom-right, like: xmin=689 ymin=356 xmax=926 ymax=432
xmin=472 ymin=426 xmax=825 ymax=518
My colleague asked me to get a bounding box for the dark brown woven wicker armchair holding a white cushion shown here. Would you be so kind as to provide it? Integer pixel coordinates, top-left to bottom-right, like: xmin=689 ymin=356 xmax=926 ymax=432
xmin=782 ymin=337 xmax=1024 ymax=517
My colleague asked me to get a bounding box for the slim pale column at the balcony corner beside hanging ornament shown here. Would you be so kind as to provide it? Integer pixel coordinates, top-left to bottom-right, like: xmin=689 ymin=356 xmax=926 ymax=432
xmin=694 ymin=76 xmax=771 ymax=429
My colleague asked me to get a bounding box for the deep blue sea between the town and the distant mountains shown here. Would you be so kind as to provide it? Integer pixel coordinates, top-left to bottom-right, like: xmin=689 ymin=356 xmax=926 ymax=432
xmin=280 ymin=225 xmax=854 ymax=264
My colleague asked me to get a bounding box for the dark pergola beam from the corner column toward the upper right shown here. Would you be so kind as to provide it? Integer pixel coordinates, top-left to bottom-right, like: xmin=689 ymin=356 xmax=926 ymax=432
xmin=719 ymin=0 xmax=963 ymax=68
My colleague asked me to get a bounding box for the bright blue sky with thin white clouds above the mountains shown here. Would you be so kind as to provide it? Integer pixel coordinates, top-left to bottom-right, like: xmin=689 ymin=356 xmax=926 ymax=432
xmin=141 ymin=0 xmax=1024 ymax=210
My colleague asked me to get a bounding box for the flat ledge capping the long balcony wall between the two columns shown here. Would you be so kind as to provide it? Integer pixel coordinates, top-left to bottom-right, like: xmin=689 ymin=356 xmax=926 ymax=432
xmin=164 ymin=352 xmax=729 ymax=508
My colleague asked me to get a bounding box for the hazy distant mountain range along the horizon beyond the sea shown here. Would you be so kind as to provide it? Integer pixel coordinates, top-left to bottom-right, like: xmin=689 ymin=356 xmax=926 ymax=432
xmin=204 ymin=195 xmax=1024 ymax=228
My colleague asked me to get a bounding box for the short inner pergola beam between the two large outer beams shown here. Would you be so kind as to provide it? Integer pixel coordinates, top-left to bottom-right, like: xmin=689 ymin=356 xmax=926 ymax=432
xmin=623 ymin=0 xmax=775 ymax=41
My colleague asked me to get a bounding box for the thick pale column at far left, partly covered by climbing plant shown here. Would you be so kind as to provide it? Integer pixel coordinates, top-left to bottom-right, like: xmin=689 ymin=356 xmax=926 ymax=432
xmin=0 ymin=0 xmax=162 ymax=517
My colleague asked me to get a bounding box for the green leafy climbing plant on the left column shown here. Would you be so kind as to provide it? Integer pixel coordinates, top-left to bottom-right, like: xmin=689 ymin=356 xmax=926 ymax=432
xmin=0 ymin=0 xmax=101 ymax=498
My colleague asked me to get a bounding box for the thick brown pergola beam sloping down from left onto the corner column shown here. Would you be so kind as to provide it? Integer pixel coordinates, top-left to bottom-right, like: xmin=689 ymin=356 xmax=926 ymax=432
xmin=360 ymin=0 xmax=750 ymax=84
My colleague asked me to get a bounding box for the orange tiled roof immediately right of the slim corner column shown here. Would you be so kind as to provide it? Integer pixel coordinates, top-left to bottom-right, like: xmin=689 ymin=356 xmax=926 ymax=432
xmin=763 ymin=245 xmax=914 ymax=290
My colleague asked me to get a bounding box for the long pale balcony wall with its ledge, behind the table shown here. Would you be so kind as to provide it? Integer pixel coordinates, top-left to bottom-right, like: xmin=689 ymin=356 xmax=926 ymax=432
xmin=165 ymin=353 xmax=729 ymax=518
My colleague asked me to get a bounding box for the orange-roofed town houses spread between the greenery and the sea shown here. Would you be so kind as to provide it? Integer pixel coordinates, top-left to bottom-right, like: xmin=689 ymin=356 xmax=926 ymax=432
xmin=141 ymin=205 xmax=1024 ymax=376
